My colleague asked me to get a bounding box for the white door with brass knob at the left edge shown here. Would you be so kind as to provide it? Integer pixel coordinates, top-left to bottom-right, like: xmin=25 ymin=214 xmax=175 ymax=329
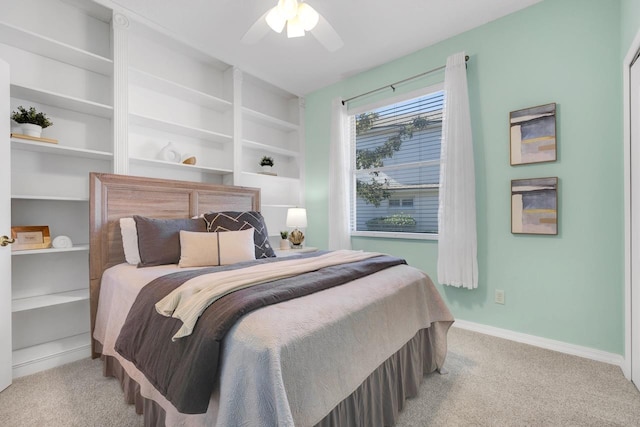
xmin=0 ymin=59 xmax=12 ymax=391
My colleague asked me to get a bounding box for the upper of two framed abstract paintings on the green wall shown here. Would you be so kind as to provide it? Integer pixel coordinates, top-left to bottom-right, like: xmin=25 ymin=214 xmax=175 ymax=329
xmin=509 ymin=103 xmax=556 ymax=166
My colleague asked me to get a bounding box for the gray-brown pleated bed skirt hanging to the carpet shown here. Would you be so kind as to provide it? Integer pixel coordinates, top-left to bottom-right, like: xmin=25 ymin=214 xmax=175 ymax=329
xmin=100 ymin=321 xmax=453 ymax=427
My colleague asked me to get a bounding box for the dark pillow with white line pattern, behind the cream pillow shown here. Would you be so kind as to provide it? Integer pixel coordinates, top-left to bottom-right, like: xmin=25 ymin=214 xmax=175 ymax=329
xmin=204 ymin=211 xmax=276 ymax=259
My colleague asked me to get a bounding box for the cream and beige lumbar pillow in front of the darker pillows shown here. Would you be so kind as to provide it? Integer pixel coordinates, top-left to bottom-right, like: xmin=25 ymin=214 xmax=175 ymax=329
xmin=178 ymin=228 xmax=256 ymax=267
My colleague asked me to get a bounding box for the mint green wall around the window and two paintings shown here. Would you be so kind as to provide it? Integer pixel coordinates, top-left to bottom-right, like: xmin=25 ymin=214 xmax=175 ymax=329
xmin=306 ymin=0 xmax=639 ymax=354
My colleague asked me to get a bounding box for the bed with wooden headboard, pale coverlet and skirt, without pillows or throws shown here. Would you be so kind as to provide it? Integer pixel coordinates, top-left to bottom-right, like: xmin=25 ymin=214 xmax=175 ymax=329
xmin=90 ymin=173 xmax=453 ymax=426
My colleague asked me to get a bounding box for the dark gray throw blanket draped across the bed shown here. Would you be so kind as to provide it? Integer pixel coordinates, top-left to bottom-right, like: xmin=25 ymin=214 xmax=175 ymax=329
xmin=115 ymin=252 xmax=406 ymax=414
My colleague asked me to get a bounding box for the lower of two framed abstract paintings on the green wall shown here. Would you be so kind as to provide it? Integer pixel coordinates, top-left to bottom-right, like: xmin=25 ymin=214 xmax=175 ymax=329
xmin=511 ymin=177 xmax=558 ymax=234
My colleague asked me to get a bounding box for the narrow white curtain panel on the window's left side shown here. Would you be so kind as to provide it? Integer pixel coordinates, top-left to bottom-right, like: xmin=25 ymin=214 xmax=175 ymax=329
xmin=328 ymin=98 xmax=352 ymax=250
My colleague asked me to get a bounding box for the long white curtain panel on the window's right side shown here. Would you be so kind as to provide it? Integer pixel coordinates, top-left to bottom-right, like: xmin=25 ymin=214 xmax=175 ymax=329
xmin=438 ymin=52 xmax=478 ymax=289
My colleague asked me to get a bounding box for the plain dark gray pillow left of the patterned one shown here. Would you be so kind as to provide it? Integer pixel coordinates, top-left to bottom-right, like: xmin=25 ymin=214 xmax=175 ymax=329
xmin=133 ymin=215 xmax=207 ymax=267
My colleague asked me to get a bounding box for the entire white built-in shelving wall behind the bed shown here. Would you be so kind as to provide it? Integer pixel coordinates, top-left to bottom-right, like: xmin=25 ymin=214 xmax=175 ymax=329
xmin=0 ymin=0 xmax=304 ymax=382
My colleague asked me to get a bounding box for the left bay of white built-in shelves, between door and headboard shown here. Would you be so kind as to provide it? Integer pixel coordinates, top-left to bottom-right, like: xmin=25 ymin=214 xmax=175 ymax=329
xmin=0 ymin=0 xmax=114 ymax=377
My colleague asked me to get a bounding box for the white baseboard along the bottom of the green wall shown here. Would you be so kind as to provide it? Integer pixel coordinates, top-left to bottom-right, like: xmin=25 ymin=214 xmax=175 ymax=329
xmin=453 ymin=319 xmax=625 ymax=369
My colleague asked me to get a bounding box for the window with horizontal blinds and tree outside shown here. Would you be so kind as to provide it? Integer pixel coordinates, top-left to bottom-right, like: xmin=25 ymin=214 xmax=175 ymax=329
xmin=350 ymin=86 xmax=444 ymax=238
